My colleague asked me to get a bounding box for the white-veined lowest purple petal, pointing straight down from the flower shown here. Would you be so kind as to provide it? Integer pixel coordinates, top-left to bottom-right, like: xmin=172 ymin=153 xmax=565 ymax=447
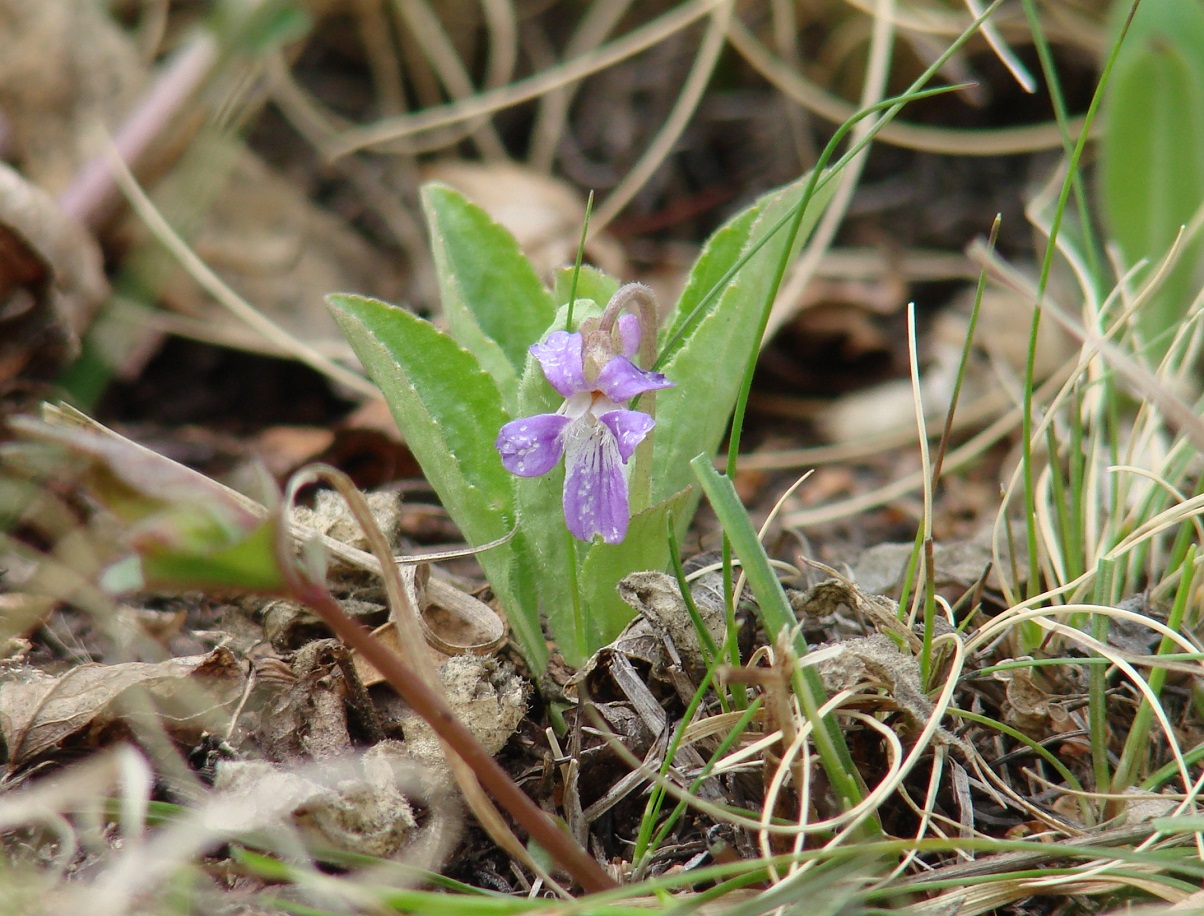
xmin=565 ymin=421 xmax=628 ymax=544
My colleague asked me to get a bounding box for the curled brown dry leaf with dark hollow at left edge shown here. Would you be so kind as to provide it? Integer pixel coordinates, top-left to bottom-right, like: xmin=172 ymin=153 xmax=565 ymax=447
xmin=0 ymin=164 xmax=108 ymax=383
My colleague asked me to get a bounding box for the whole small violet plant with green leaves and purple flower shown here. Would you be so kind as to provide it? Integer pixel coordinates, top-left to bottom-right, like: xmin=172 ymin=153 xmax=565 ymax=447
xmin=329 ymin=176 xmax=827 ymax=673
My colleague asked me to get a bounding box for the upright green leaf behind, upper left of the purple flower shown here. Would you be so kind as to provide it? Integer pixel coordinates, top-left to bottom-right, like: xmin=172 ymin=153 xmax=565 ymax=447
xmin=423 ymin=184 xmax=555 ymax=409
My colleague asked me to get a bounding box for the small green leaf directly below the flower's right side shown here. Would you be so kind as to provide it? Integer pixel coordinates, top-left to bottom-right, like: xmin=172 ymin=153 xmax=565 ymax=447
xmin=570 ymin=490 xmax=690 ymax=666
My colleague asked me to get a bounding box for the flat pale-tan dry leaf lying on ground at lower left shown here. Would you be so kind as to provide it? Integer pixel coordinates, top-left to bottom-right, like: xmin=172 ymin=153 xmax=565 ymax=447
xmin=0 ymin=649 xmax=243 ymax=772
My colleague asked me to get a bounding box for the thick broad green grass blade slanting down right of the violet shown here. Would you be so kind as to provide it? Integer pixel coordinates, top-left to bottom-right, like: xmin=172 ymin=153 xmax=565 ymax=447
xmin=690 ymin=455 xmax=881 ymax=838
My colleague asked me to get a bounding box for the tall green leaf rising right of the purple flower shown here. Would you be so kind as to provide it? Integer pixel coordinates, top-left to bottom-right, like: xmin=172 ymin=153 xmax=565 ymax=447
xmin=653 ymin=176 xmax=834 ymax=507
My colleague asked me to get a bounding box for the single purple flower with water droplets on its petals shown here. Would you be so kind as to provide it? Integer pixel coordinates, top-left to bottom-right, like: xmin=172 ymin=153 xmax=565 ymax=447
xmin=497 ymin=314 xmax=673 ymax=544
